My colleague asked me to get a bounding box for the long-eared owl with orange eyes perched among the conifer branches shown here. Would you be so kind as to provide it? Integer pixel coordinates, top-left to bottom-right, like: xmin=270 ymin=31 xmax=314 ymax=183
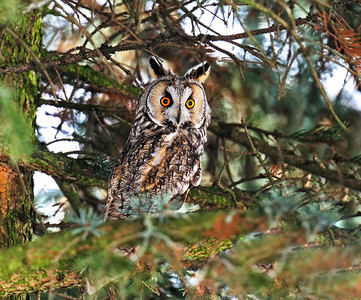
xmin=104 ymin=57 xmax=211 ymax=220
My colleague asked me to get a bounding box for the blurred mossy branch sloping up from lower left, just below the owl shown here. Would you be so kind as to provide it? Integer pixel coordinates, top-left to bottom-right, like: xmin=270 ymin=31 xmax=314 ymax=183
xmin=0 ymin=212 xmax=267 ymax=297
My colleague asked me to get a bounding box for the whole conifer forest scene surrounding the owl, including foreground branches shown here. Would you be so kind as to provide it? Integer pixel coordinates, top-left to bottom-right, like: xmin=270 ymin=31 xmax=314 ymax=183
xmin=0 ymin=0 xmax=361 ymax=299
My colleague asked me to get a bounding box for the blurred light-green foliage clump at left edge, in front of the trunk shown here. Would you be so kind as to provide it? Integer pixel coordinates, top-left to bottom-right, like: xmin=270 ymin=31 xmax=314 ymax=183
xmin=0 ymin=86 xmax=34 ymax=162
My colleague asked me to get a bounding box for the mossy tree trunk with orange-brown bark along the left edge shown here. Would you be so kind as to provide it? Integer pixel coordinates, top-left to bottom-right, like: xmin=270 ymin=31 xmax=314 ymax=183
xmin=0 ymin=12 xmax=42 ymax=248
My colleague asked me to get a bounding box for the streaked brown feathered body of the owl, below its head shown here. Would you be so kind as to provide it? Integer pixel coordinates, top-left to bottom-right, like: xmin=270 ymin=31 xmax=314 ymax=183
xmin=105 ymin=126 xmax=204 ymax=216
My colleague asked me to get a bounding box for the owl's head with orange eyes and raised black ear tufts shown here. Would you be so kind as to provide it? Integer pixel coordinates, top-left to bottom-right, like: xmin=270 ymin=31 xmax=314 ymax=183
xmin=137 ymin=56 xmax=210 ymax=128
